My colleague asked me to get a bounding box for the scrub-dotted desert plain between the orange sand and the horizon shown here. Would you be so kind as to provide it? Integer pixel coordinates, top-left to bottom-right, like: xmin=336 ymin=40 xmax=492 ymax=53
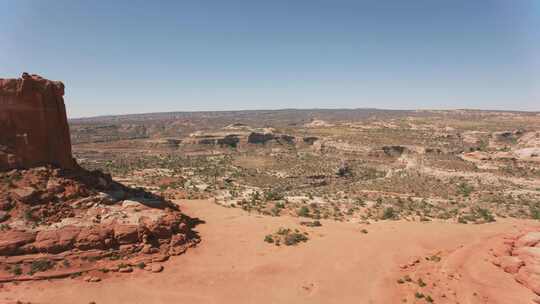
xmin=74 ymin=112 xmax=540 ymax=228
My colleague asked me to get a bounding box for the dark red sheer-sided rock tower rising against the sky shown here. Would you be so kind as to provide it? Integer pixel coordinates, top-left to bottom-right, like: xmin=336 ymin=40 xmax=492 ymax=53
xmin=0 ymin=73 xmax=76 ymax=170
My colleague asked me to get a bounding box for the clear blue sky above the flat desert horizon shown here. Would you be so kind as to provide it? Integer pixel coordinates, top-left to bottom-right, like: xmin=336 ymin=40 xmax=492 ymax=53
xmin=0 ymin=0 xmax=540 ymax=117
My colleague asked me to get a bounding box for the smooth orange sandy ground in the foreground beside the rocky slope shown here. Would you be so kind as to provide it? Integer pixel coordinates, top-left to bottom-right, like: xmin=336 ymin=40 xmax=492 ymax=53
xmin=0 ymin=201 xmax=538 ymax=304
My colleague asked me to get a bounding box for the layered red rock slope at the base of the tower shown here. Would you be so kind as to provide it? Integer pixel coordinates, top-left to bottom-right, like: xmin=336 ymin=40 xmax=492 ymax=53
xmin=0 ymin=167 xmax=199 ymax=283
